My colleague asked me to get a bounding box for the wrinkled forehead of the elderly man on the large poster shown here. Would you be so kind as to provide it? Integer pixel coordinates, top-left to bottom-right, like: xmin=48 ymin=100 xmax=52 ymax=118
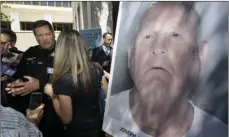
xmin=141 ymin=4 xmax=198 ymax=39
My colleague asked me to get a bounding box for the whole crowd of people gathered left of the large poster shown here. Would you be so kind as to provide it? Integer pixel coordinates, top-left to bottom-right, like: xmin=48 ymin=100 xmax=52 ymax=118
xmin=0 ymin=20 xmax=112 ymax=137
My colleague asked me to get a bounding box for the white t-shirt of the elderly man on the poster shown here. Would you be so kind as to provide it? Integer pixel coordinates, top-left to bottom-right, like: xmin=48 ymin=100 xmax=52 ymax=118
xmin=104 ymin=90 xmax=228 ymax=137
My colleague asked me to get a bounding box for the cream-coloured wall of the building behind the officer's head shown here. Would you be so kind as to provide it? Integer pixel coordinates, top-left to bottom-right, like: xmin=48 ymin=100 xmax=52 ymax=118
xmin=1 ymin=4 xmax=73 ymax=51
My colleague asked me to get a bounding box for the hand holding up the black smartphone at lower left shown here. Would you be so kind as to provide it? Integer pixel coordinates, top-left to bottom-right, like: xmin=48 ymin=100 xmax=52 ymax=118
xmin=26 ymin=103 xmax=45 ymax=125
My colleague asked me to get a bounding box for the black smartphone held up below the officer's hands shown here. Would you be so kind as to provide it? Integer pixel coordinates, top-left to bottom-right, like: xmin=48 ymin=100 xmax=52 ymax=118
xmin=29 ymin=92 xmax=42 ymax=110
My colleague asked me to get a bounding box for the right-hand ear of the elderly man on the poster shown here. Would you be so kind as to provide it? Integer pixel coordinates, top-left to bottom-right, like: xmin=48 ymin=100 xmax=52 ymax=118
xmin=198 ymin=40 xmax=209 ymax=70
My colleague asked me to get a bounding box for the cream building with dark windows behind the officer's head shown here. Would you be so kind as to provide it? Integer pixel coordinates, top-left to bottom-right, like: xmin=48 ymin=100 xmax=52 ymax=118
xmin=1 ymin=1 xmax=73 ymax=51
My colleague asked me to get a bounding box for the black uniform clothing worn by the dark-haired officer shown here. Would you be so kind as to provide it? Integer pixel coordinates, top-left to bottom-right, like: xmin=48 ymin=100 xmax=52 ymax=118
xmin=14 ymin=46 xmax=64 ymax=137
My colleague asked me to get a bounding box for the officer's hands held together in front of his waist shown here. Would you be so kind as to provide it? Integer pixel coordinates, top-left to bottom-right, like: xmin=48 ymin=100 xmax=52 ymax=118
xmin=6 ymin=76 xmax=40 ymax=96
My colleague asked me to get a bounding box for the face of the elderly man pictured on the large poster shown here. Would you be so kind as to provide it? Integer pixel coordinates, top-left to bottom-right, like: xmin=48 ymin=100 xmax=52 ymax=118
xmin=134 ymin=5 xmax=200 ymax=99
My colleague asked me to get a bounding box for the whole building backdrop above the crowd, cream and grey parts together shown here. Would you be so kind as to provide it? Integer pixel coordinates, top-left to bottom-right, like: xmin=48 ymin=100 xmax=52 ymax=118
xmin=1 ymin=1 xmax=119 ymax=51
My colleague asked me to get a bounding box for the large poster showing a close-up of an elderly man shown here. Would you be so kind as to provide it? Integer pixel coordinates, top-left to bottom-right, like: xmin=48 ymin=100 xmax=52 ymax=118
xmin=103 ymin=1 xmax=228 ymax=137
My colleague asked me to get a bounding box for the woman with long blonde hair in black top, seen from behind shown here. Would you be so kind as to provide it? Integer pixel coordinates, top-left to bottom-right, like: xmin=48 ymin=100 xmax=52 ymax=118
xmin=45 ymin=30 xmax=104 ymax=137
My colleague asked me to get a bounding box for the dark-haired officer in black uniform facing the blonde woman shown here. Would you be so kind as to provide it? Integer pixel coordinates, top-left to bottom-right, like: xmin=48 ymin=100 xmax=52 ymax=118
xmin=6 ymin=20 xmax=64 ymax=137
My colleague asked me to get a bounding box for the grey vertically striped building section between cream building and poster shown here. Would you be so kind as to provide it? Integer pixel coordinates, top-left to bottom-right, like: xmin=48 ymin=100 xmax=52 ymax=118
xmin=72 ymin=1 xmax=119 ymax=46
